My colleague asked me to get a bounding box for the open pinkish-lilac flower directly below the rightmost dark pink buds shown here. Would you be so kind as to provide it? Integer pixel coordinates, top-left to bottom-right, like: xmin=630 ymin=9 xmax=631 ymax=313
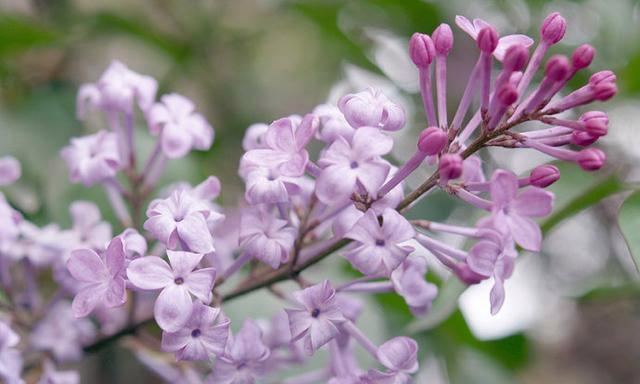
xmin=490 ymin=170 xmax=553 ymax=251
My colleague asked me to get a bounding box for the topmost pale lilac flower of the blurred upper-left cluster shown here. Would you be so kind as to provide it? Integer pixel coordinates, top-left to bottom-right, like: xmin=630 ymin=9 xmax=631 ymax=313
xmin=77 ymin=60 xmax=158 ymax=119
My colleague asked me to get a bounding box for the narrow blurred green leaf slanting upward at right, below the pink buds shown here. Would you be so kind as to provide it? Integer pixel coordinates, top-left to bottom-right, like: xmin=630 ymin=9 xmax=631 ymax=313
xmin=541 ymin=174 xmax=627 ymax=233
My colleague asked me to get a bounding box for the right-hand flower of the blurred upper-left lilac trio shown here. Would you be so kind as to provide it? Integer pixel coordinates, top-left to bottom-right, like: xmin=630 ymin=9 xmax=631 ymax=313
xmin=147 ymin=93 xmax=213 ymax=159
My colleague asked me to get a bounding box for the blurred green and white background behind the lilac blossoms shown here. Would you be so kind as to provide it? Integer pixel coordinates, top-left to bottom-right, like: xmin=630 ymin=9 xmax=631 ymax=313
xmin=0 ymin=0 xmax=640 ymax=384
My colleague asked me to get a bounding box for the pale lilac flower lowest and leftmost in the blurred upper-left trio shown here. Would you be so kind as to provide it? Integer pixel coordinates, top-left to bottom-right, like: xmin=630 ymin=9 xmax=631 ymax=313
xmin=60 ymin=131 xmax=121 ymax=187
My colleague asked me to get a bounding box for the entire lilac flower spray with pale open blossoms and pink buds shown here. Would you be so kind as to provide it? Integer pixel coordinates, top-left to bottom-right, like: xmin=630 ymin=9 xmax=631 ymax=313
xmin=0 ymin=13 xmax=616 ymax=384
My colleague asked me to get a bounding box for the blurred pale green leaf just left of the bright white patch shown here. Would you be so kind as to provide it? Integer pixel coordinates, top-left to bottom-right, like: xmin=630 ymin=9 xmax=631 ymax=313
xmin=407 ymin=276 xmax=467 ymax=333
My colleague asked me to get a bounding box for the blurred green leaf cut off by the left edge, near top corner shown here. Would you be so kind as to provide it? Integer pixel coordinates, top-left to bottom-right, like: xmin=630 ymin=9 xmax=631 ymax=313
xmin=0 ymin=15 xmax=62 ymax=56
